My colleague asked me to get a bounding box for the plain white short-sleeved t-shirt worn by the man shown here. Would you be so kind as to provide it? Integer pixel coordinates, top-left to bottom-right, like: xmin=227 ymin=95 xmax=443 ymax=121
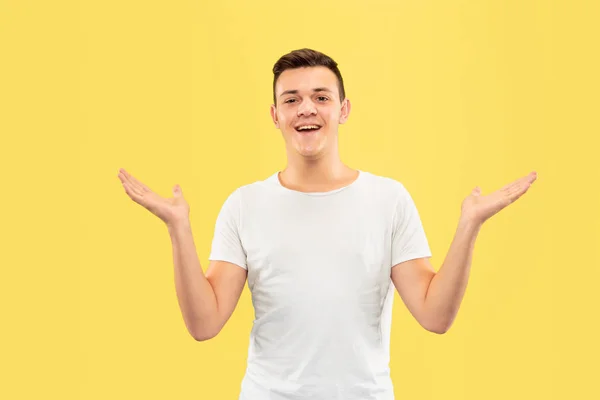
xmin=209 ymin=171 xmax=431 ymax=400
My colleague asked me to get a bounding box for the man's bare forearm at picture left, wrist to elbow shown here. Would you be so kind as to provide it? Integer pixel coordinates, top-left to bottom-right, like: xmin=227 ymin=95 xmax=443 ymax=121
xmin=167 ymin=220 xmax=217 ymax=339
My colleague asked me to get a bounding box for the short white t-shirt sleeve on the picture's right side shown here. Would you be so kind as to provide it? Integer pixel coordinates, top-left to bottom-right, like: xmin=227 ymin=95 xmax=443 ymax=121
xmin=392 ymin=184 xmax=431 ymax=267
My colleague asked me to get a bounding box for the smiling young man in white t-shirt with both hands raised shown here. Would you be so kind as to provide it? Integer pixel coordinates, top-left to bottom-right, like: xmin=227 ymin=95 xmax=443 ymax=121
xmin=119 ymin=49 xmax=536 ymax=400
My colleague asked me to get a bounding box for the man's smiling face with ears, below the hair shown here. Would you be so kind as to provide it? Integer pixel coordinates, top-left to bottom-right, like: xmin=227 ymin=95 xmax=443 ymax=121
xmin=271 ymin=67 xmax=350 ymax=159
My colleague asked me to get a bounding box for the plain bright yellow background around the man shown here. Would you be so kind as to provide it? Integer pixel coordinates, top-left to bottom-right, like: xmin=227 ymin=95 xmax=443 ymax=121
xmin=0 ymin=0 xmax=600 ymax=400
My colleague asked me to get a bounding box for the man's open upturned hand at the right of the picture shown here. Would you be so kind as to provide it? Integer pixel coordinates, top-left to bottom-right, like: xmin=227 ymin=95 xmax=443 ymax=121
xmin=462 ymin=172 xmax=537 ymax=223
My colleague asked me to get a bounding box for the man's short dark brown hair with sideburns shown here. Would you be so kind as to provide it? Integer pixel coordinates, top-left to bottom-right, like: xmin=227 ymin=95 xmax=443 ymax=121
xmin=273 ymin=48 xmax=346 ymax=105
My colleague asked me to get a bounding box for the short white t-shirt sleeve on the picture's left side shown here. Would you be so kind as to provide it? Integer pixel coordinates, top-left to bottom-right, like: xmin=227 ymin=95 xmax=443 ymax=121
xmin=208 ymin=189 xmax=248 ymax=270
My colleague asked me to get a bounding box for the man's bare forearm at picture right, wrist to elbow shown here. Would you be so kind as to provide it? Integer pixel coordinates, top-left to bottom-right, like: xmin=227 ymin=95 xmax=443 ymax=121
xmin=425 ymin=218 xmax=481 ymax=332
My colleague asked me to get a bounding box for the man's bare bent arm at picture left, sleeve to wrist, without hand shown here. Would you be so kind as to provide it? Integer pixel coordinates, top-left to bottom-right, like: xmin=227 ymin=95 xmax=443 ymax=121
xmin=167 ymin=220 xmax=247 ymax=341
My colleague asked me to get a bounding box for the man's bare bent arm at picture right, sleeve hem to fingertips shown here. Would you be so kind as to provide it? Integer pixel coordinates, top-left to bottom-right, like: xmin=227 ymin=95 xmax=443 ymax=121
xmin=391 ymin=172 xmax=537 ymax=334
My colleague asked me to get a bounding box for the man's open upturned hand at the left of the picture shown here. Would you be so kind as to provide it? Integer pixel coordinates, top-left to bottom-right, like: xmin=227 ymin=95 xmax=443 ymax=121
xmin=119 ymin=168 xmax=190 ymax=225
